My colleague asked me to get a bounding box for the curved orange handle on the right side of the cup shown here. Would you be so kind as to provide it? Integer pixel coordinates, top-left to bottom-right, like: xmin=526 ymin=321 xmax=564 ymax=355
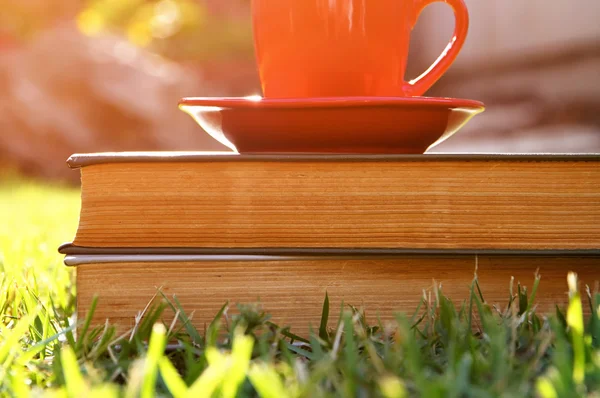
xmin=404 ymin=0 xmax=469 ymax=97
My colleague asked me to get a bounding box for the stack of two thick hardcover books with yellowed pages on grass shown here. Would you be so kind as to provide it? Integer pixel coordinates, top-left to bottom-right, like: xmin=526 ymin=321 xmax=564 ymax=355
xmin=60 ymin=152 xmax=600 ymax=332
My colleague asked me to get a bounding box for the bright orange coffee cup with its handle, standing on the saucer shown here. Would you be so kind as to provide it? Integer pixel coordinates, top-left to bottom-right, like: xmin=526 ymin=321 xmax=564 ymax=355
xmin=252 ymin=0 xmax=469 ymax=98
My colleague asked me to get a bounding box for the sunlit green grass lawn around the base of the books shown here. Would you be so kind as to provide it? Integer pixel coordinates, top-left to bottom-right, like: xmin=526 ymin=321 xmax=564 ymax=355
xmin=0 ymin=180 xmax=600 ymax=397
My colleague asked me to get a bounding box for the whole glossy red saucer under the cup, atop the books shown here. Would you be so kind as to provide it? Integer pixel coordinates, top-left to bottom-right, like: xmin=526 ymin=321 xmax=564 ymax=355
xmin=179 ymin=97 xmax=484 ymax=154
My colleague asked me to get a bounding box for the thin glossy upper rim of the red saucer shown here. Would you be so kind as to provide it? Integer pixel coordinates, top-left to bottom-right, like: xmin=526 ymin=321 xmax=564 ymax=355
xmin=178 ymin=97 xmax=485 ymax=111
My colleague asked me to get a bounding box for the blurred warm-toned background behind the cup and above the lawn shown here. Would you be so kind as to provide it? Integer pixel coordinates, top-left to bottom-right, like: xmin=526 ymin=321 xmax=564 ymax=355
xmin=0 ymin=0 xmax=600 ymax=181
